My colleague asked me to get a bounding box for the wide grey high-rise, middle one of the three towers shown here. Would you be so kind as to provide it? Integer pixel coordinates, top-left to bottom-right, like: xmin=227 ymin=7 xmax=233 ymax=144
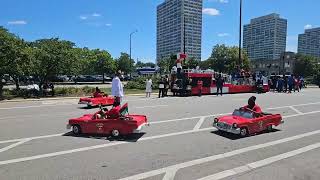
xmin=243 ymin=13 xmax=287 ymax=60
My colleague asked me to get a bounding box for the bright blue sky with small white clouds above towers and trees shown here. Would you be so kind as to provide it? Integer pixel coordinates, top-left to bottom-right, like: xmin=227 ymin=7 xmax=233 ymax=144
xmin=0 ymin=0 xmax=320 ymax=62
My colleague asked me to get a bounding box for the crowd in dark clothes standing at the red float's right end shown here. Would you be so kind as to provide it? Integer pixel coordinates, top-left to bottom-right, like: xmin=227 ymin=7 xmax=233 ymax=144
xmin=269 ymin=75 xmax=305 ymax=93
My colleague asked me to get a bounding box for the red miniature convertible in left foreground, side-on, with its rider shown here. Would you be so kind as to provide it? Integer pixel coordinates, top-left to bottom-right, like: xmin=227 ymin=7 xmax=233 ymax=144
xmin=67 ymin=104 xmax=147 ymax=137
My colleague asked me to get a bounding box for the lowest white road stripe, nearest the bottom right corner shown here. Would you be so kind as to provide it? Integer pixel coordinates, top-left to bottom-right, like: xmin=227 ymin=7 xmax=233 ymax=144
xmin=198 ymin=143 xmax=320 ymax=180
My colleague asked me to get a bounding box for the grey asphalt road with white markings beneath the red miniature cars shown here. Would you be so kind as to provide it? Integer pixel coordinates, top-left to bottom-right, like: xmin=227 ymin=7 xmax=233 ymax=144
xmin=0 ymin=89 xmax=320 ymax=180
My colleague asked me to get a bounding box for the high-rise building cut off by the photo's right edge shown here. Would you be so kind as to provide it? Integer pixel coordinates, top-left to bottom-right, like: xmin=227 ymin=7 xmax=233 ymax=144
xmin=298 ymin=28 xmax=320 ymax=58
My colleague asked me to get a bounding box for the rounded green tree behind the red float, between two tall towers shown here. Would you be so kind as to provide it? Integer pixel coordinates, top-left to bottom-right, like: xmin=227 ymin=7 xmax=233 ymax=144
xmin=208 ymin=44 xmax=250 ymax=73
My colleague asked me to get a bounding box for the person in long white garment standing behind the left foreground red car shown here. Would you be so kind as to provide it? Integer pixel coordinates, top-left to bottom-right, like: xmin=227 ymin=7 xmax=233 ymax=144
xmin=111 ymin=71 xmax=124 ymax=107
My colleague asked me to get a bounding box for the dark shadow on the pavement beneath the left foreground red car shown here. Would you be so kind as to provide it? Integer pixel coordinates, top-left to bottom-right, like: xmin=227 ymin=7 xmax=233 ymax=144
xmin=62 ymin=132 xmax=145 ymax=142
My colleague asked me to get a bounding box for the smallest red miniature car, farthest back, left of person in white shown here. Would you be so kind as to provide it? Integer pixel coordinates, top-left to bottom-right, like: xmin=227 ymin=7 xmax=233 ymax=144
xmin=78 ymin=96 xmax=114 ymax=107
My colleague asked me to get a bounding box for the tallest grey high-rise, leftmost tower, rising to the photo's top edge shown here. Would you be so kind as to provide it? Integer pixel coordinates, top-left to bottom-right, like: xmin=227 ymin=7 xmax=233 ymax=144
xmin=157 ymin=0 xmax=202 ymax=61
